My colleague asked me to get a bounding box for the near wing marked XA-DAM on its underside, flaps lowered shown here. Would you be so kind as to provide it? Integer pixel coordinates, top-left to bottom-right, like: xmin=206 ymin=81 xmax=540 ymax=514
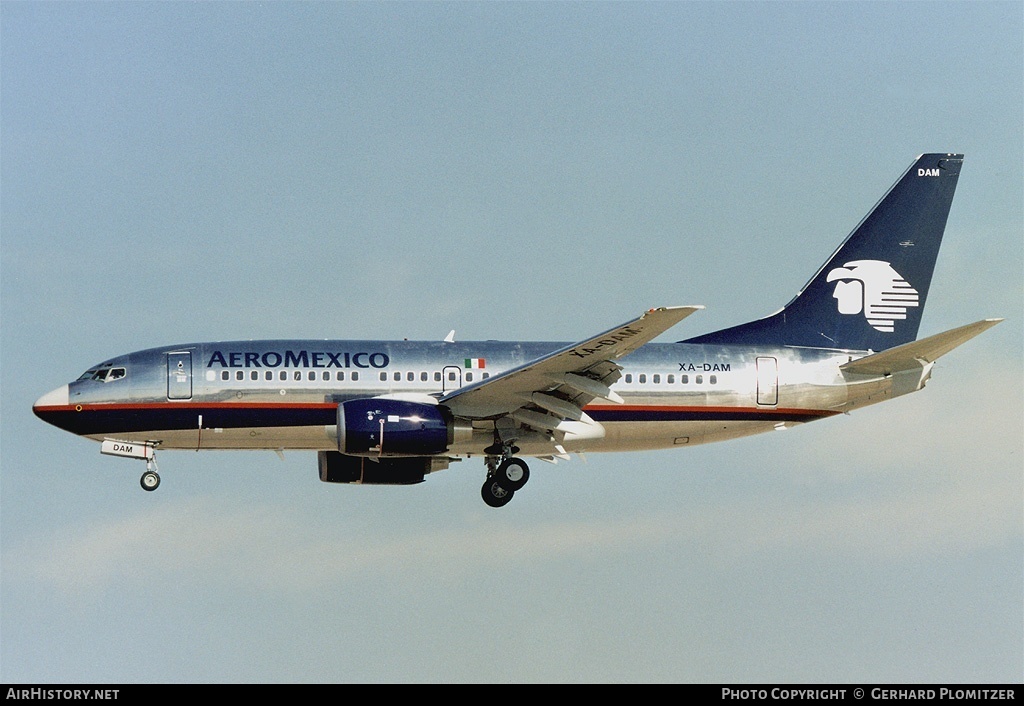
xmin=439 ymin=306 xmax=703 ymax=424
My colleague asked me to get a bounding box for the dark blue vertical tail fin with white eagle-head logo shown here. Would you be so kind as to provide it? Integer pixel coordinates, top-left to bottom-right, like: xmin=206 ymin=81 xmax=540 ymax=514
xmin=684 ymin=155 xmax=964 ymax=350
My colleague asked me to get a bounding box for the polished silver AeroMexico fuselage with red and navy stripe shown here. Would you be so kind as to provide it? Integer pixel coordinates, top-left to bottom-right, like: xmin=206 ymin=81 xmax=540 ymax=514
xmin=37 ymin=340 xmax=913 ymax=456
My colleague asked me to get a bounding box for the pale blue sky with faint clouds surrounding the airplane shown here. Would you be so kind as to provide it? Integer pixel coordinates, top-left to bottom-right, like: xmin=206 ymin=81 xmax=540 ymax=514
xmin=0 ymin=2 xmax=1024 ymax=682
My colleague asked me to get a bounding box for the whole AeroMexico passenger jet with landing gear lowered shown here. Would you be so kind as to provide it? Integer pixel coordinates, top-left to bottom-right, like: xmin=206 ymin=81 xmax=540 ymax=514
xmin=33 ymin=154 xmax=1002 ymax=507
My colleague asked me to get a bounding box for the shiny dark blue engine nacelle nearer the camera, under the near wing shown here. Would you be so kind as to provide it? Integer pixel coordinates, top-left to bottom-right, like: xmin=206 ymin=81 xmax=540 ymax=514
xmin=338 ymin=398 xmax=455 ymax=456
